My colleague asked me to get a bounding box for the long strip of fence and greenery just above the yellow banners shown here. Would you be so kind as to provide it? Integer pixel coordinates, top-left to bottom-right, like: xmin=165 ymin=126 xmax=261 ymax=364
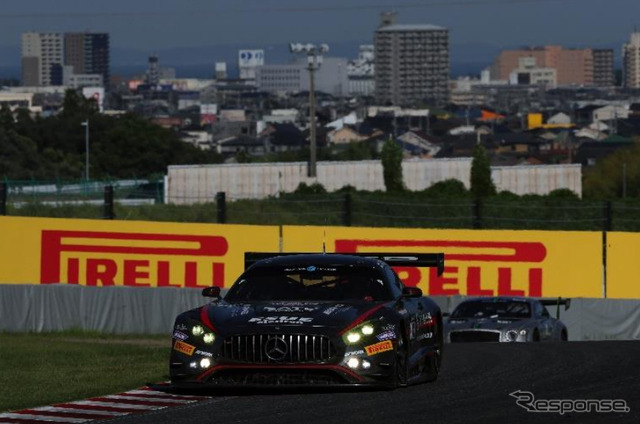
xmin=0 ymin=180 xmax=640 ymax=231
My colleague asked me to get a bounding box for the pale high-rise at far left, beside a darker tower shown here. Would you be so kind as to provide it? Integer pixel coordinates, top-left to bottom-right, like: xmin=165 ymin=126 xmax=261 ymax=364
xmin=21 ymin=32 xmax=64 ymax=86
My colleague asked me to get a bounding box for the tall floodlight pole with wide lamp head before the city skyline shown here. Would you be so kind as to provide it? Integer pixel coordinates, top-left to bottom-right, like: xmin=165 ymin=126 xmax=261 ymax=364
xmin=289 ymin=43 xmax=329 ymax=178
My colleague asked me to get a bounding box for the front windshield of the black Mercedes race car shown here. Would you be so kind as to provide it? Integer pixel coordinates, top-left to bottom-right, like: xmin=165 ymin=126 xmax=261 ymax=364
xmin=225 ymin=266 xmax=392 ymax=302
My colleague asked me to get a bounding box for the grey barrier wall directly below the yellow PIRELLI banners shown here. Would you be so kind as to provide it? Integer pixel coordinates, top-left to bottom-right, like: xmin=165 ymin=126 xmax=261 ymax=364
xmin=0 ymin=285 xmax=640 ymax=341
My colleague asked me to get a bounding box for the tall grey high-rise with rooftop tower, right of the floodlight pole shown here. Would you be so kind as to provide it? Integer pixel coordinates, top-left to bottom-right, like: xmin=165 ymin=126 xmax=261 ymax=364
xmin=375 ymin=13 xmax=450 ymax=106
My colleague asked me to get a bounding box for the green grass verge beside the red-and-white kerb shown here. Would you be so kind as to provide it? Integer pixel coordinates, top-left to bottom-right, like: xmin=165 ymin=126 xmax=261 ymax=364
xmin=0 ymin=331 xmax=171 ymax=411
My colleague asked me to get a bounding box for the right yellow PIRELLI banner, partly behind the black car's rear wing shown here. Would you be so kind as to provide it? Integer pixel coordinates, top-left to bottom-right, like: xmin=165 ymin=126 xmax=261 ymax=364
xmin=283 ymin=227 xmax=604 ymax=297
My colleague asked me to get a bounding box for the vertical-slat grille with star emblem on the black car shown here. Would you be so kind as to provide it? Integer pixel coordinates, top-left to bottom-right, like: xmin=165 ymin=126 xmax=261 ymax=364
xmin=221 ymin=334 xmax=336 ymax=364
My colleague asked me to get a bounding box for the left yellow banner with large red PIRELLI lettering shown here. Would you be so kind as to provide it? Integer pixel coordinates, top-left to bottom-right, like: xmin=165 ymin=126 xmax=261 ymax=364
xmin=0 ymin=217 xmax=279 ymax=288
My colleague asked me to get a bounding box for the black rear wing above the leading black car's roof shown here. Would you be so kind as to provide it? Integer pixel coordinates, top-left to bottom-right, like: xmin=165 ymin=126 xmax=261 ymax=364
xmin=244 ymin=252 xmax=444 ymax=276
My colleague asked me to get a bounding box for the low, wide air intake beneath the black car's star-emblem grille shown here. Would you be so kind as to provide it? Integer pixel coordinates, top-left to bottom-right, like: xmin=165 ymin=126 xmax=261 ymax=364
xmin=209 ymin=370 xmax=347 ymax=386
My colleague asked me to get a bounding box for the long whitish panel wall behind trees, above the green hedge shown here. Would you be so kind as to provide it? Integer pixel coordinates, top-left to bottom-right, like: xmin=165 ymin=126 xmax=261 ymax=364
xmin=167 ymin=158 xmax=582 ymax=204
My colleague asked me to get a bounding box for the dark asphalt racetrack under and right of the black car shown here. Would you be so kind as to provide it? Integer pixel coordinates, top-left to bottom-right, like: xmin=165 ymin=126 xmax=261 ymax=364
xmin=103 ymin=341 xmax=640 ymax=424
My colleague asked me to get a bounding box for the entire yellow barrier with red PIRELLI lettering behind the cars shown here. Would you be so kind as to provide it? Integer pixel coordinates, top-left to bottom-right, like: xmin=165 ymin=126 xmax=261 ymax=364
xmin=0 ymin=217 xmax=640 ymax=298
